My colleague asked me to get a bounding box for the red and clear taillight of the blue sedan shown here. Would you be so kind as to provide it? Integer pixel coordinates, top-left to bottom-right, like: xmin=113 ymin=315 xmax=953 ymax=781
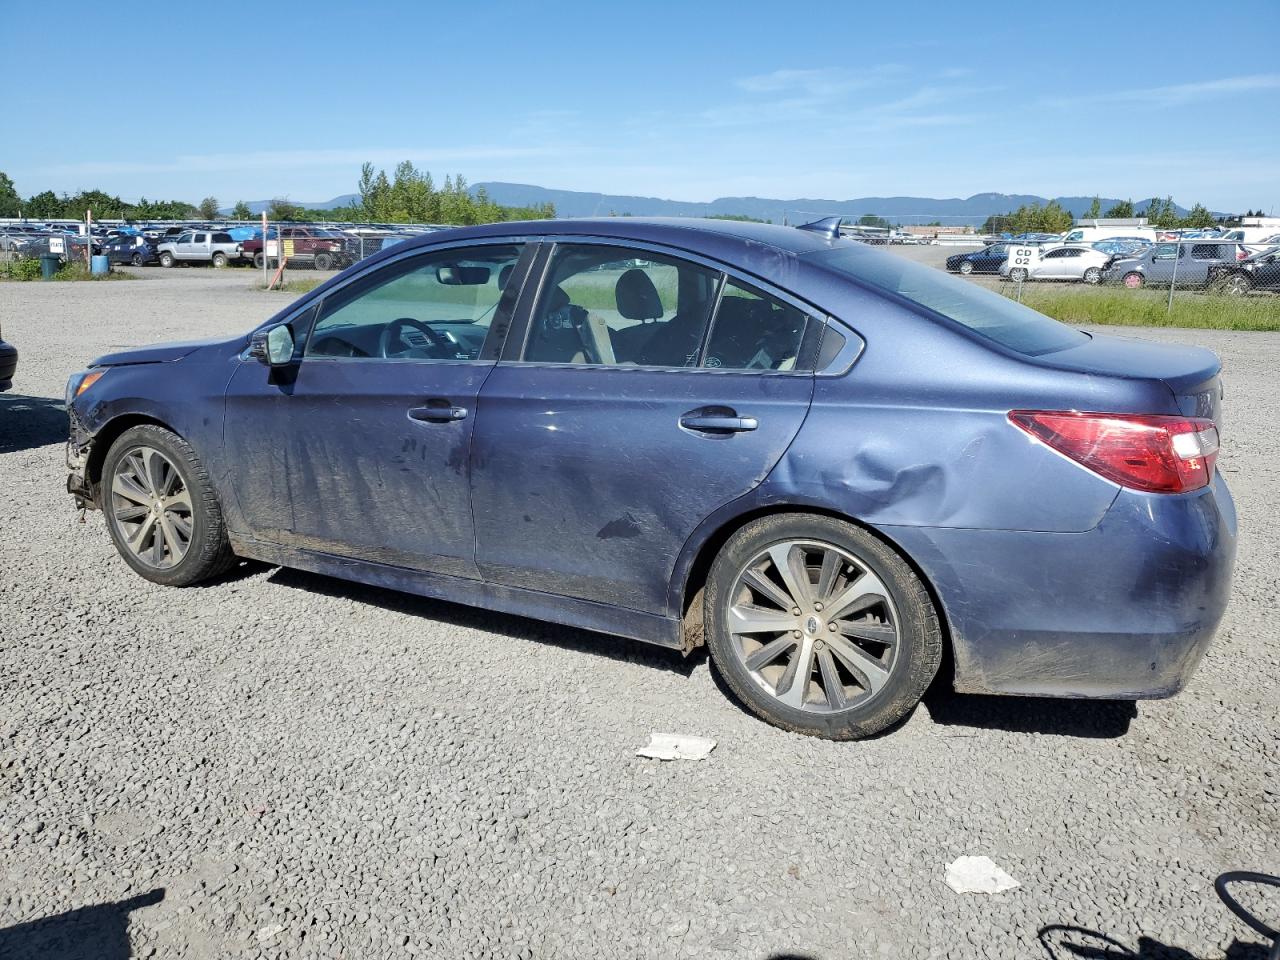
xmin=1009 ymin=410 xmax=1217 ymax=493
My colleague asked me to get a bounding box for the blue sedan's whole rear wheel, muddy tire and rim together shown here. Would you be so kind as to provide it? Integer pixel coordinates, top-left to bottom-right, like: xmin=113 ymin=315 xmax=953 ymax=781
xmin=703 ymin=513 xmax=942 ymax=740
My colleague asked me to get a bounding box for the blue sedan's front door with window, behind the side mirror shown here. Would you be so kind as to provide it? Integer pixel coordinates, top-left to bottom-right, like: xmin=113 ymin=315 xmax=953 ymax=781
xmin=225 ymin=241 xmax=532 ymax=579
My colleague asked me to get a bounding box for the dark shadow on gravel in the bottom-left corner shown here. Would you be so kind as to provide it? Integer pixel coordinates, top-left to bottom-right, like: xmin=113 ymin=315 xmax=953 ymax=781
xmin=0 ymin=887 xmax=164 ymax=960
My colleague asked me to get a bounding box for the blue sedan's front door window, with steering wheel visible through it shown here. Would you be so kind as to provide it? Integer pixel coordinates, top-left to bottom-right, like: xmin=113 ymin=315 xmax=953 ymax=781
xmin=306 ymin=244 xmax=521 ymax=360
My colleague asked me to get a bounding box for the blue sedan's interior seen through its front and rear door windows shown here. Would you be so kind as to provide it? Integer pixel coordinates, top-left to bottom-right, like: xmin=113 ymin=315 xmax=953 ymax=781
xmin=306 ymin=244 xmax=808 ymax=371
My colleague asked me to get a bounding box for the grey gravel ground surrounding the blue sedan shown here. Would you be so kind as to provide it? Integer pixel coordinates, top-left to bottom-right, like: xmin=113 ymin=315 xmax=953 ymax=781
xmin=0 ymin=270 xmax=1280 ymax=960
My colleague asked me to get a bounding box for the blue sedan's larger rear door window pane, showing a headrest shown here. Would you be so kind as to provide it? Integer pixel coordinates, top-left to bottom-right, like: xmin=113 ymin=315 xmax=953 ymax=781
xmin=524 ymin=243 xmax=721 ymax=366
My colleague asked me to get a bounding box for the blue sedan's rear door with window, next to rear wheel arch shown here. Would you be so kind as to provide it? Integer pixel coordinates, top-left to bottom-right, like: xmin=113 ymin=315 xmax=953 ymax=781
xmin=471 ymin=241 xmax=822 ymax=616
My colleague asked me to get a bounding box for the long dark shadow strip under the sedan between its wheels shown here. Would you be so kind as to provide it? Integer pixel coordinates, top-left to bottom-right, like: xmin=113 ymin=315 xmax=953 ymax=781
xmin=268 ymin=567 xmax=701 ymax=677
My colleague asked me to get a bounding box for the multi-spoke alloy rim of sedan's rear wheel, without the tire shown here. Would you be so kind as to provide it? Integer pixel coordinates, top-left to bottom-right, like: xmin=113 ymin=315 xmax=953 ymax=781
xmin=726 ymin=540 xmax=901 ymax=713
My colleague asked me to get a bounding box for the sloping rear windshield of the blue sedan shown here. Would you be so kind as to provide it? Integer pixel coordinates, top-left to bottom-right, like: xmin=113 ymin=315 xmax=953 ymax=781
xmin=805 ymin=246 xmax=1088 ymax=356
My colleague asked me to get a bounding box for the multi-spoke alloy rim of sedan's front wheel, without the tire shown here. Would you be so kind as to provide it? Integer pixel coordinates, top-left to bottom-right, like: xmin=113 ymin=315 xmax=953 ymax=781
xmin=110 ymin=447 xmax=195 ymax=570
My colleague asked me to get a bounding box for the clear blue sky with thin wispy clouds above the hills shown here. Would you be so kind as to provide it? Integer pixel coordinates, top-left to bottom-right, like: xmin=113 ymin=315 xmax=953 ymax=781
xmin=0 ymin=0 xmax=1280 ymax=214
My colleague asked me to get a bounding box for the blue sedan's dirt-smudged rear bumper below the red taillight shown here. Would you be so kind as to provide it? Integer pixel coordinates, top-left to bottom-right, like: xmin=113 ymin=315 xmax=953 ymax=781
xmin=884 ymin=476 xmax=1236 ymax=699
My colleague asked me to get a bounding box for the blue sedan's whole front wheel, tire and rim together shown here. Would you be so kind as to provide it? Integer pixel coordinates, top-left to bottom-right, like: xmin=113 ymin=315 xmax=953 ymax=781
xmin=99 ymin=424 xmax=236 ymax=586
